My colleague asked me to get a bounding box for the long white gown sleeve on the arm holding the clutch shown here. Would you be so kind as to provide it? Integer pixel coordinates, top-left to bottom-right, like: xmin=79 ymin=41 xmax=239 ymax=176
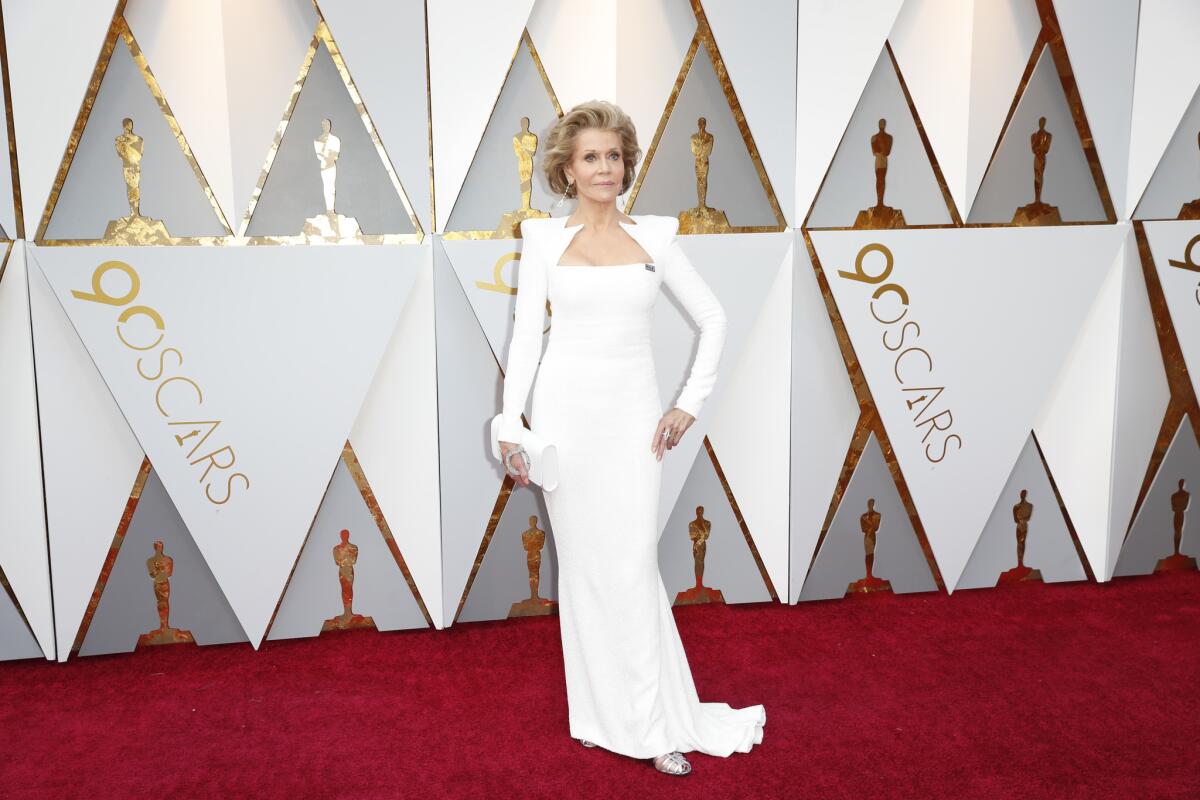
xmin=499 ymin=222 xmax=546 ymax=443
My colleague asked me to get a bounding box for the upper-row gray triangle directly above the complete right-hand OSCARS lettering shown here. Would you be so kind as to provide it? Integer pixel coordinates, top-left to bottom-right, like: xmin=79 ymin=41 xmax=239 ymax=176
xmin=808 ymin=49 xmax=954 ymax=228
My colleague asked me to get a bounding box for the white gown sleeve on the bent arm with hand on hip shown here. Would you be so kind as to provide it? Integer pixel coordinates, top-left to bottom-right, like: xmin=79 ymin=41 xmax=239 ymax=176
xmin=661 ymin=231 xmax=728 ymax=416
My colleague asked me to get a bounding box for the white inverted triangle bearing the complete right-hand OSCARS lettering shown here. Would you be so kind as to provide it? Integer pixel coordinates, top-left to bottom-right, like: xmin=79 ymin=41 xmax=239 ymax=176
xmin=812 ymin=227 xmax=1124 ymax=587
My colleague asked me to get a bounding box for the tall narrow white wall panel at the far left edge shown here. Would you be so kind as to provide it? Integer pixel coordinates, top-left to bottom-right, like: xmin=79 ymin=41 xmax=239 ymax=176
xmin=0 ymin=241 xmax=54 ymax=660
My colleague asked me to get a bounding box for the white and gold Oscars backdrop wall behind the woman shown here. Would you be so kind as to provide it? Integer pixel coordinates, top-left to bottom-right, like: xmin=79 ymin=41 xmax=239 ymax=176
xmin=0 ymin=0 xmax=1200 ymax=661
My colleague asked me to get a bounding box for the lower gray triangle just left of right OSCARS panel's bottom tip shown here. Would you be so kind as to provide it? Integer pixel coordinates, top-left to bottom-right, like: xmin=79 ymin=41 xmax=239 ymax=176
xmin=793 ymin=434 xmax=937 ymax=601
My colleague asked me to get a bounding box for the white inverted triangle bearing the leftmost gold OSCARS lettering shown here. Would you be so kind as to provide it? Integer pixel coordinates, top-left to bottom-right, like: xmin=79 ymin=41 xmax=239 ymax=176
xmin=36 ymin=246 xmax=412 ymax=645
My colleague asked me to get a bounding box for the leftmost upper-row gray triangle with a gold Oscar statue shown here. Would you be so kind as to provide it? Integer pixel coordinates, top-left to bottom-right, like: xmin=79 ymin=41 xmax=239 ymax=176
xmin=46 ymin=37 xmax=228 ymax=239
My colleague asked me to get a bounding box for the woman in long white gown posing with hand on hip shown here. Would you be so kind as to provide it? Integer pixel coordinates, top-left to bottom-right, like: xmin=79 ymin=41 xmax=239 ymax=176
xmin=499 ymin=101 xmax=767 ymax=775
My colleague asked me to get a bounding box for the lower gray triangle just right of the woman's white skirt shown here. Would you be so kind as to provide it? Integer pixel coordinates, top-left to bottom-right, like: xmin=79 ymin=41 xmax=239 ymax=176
xmin=659 ymin=447 xmax=770 ymax=603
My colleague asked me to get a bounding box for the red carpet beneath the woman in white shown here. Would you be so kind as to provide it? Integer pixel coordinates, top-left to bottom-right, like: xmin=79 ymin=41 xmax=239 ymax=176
xmin=0 ymin=572 xmax=1200 ymax=800
